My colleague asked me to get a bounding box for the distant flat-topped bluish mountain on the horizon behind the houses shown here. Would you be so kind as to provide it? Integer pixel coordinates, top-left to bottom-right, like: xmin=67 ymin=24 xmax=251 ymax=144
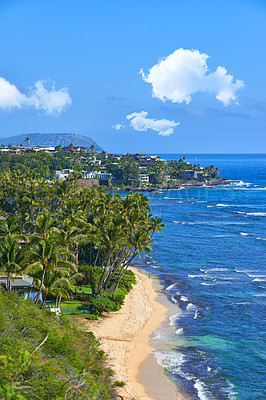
xmin=0 ymin=133 xmax=103 ymax=151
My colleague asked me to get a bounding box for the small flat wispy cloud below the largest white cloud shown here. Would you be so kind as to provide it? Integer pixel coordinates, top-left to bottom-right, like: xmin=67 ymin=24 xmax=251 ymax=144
xmin=126 ymin=111 xmax=180 ymax=136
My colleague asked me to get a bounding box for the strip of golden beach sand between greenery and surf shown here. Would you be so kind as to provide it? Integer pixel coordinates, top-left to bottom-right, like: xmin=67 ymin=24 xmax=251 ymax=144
xmin=80 ymin=268 xmax=187 ymax=400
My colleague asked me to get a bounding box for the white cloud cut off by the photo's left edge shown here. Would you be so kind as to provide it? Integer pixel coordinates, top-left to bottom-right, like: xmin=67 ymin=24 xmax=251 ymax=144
xmin=0 ymin=77 xmax=72 ymax=115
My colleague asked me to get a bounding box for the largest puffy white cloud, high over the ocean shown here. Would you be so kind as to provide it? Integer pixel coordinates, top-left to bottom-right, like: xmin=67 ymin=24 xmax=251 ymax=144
xmin=140 ymin=48 xmax=244 ymax=106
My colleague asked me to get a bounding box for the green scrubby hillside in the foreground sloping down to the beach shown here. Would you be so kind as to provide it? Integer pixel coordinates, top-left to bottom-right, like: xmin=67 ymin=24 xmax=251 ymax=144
xmin=0 ymin=291 xmax=114 ymax=400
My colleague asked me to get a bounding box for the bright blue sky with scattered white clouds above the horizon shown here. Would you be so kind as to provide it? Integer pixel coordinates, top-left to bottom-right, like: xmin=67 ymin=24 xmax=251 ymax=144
xmin=0 ymin=0 xmax=266 ymax=154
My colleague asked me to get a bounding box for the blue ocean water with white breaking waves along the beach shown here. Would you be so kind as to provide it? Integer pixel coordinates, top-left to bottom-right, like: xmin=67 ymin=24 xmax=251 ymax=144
xmin=140 ymin=154 xmax=266 ymax=400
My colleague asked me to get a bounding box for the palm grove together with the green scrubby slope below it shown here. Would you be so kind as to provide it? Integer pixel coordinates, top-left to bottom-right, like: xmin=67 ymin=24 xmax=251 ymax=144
xmin=0 ymin=169 xmax=164 ymax=400
